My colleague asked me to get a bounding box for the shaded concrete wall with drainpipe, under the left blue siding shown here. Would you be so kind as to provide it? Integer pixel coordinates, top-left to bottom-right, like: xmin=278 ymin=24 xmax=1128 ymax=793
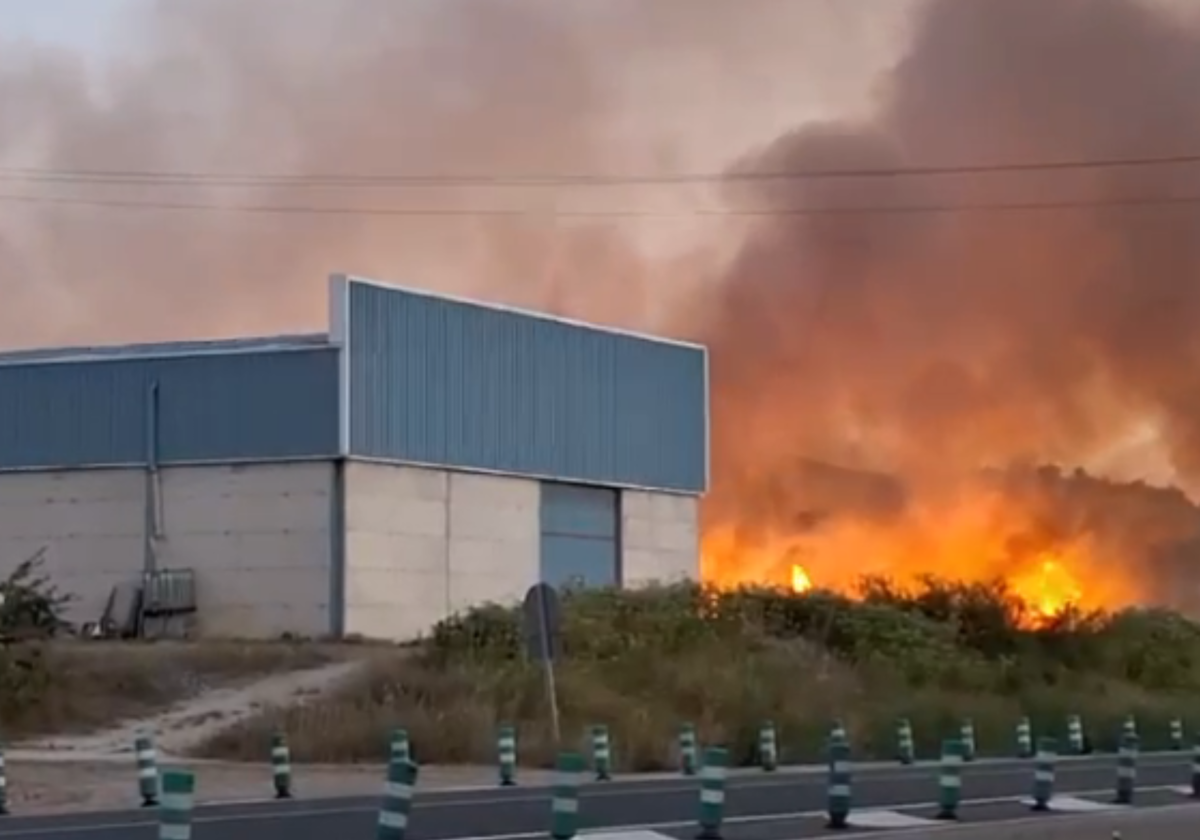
xmin=0 ymin=462 xmax=332 ymax=636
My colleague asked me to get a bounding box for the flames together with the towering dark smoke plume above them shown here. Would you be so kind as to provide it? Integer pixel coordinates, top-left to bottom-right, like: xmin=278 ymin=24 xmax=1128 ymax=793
xmin=703 ymin=0 xmax=1200 ymax=616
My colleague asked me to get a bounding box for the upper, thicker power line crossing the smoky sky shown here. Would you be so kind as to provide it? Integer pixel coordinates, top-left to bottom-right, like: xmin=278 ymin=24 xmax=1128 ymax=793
xmin=0 ymin=154 xmax=1200 ymax=188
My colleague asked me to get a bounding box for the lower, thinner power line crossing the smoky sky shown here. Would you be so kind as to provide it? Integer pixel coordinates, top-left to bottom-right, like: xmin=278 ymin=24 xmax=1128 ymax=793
xmin=0 ymin=193 xmax=1200 ymax=218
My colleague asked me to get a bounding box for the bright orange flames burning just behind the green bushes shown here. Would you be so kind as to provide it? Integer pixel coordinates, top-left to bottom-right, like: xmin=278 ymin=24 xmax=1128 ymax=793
xmin=702 ymin=484 xmax=1136 ymax=618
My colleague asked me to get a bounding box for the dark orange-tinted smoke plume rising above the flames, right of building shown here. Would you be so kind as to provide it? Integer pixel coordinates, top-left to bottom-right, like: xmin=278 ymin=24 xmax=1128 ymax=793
xmin=704 ymin=0 xmax=1200 ymax=542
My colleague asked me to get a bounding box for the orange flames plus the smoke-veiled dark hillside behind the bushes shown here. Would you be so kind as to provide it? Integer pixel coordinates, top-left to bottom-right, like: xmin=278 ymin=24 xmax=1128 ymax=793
xmin=702 ymin=464 xmax=1200 ymax=620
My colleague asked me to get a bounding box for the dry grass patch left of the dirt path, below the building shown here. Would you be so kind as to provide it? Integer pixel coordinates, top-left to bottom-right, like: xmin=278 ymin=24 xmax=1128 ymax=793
xmin=0 ymin=642 xmax=343 ymax=739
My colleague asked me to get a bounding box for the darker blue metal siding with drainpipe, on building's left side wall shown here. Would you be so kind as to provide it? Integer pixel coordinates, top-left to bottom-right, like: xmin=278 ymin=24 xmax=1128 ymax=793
xmin=0 ymin=348 xmax=338 ymax=469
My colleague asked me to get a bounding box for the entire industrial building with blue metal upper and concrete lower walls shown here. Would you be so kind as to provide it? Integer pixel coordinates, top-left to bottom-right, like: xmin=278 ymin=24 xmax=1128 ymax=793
xmin=0 ymin=276 xmax=708 ymax=640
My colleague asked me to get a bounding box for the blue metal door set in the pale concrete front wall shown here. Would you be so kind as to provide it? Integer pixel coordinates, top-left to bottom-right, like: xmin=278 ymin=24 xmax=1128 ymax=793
xmin=540 ymin=481 xmax=620 ymax=587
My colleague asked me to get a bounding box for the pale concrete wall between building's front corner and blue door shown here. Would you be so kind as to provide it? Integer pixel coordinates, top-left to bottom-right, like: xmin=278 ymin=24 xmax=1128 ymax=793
xmin=346 ymin=462 xmax=539 ymax=638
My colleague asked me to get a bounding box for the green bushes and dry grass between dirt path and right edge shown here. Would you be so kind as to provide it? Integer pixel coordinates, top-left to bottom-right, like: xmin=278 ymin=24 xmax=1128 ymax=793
xmin=192 ymin=580 xmax=1200 ymax=769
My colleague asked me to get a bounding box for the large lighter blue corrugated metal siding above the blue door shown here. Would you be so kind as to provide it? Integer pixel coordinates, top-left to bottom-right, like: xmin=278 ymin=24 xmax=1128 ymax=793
xmin=349 ymin=283 xmax=708 ymax=492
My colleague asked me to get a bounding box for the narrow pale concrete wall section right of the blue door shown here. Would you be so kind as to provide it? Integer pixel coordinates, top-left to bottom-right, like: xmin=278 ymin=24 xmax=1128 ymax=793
xmin=620 ymin=490 xmax=700 ymax=587
